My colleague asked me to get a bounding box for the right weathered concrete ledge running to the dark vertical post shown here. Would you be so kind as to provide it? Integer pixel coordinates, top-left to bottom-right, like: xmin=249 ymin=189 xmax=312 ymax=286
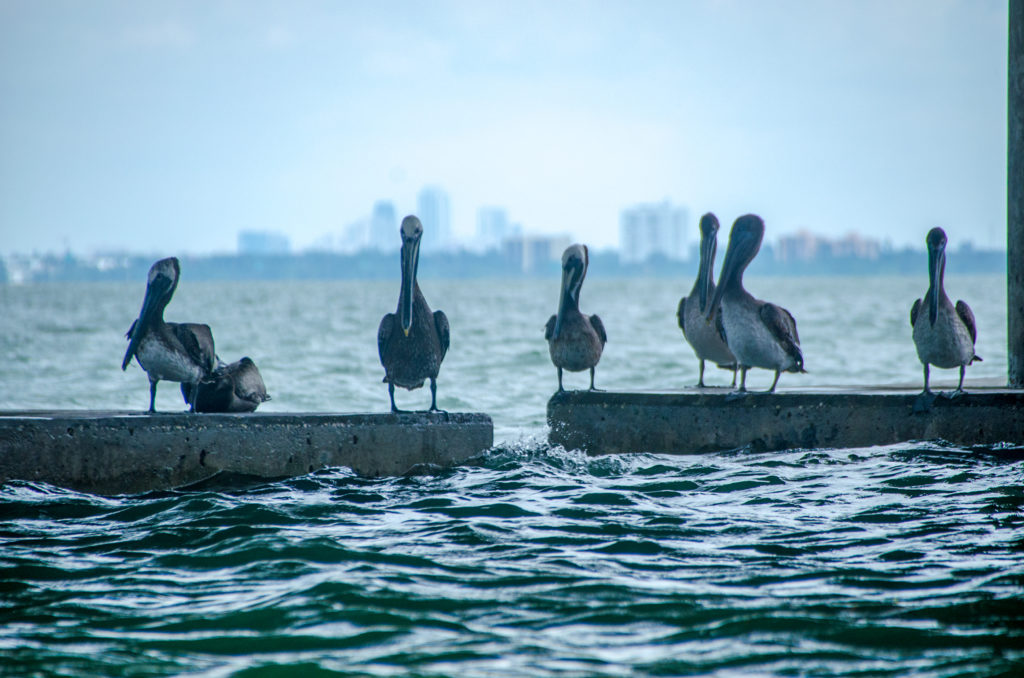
xmin=548 ymin=388 xmax=1024 ymax=454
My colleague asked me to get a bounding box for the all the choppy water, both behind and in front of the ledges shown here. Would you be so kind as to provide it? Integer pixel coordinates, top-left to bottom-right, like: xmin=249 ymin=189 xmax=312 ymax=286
xmin=0 ymin=271 xmax=1024 ymax=676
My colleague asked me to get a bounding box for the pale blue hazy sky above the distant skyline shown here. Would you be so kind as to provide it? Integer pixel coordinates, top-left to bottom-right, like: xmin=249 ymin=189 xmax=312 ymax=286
xmin=0 ymin=0 xmax=1007 ymax=254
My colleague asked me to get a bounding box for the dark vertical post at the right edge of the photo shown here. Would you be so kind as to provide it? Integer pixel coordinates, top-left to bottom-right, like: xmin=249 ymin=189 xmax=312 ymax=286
xmin=1007 ymin=0 xmax=1024 ymax=388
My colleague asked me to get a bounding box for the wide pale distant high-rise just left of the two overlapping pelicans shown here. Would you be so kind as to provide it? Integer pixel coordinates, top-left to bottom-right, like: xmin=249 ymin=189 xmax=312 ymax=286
xmin=618 ymin=201 xmax=696 ymax=263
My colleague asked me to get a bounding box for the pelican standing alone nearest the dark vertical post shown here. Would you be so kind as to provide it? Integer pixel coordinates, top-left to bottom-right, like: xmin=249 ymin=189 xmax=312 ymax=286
xmin=910 ymin=228 xmax=981 ymax=394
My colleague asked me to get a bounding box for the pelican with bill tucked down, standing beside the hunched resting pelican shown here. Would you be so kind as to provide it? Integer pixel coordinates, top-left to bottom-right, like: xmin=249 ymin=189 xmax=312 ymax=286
xmin=121 ymin=257 xmax=216 ymax=412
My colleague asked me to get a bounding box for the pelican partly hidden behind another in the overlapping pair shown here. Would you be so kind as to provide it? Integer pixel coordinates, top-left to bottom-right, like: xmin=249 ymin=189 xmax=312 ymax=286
xmin=676 ymin=212 xmax=736 ymax=388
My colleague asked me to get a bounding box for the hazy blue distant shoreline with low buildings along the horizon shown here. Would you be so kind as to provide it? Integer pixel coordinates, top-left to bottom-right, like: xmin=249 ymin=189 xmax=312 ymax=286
xmin=0 ymin=231 xmax=1008 ymax=285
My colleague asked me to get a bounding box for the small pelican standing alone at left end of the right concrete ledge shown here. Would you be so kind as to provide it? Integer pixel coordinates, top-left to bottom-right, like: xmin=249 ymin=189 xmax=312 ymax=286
xmin=544 ymin=245 xmax=608 ymax=392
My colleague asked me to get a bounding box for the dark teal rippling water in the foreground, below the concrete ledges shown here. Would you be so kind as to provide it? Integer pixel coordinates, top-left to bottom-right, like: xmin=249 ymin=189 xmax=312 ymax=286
xmin=0 ymin=444 xmax=1024 ymax=676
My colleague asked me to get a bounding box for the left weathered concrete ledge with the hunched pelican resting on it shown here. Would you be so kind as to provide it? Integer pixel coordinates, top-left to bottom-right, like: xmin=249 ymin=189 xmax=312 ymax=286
xmin=0 ymin=411 xmax=494 ymax=495
